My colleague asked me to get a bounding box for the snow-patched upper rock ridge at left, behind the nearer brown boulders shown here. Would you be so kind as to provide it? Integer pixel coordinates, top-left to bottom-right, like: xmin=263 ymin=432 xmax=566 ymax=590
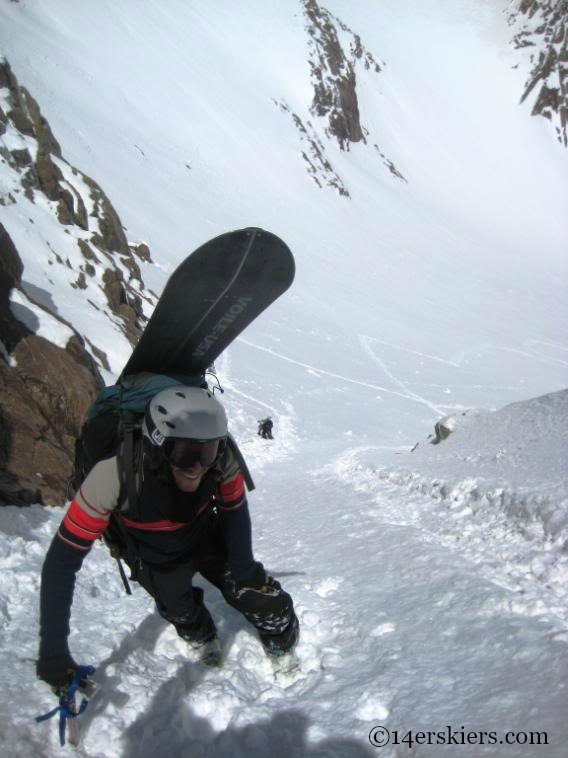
xmin=0 ymin=60 xmax=155 ymax=368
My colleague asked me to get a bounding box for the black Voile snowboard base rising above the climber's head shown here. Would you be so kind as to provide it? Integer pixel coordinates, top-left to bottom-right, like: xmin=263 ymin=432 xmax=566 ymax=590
xmin=119 ymin=227 xmax=295 ymax=381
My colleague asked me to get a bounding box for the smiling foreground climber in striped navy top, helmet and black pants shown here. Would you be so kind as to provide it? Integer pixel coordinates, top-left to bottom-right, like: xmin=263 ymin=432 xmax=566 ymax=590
xmin=37 ymin=392 xmax=299 ymax=691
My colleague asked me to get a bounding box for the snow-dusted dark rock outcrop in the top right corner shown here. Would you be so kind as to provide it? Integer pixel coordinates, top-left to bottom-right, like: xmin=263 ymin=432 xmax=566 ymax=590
xmin=509 ymin=0 xmax=568 ymax=147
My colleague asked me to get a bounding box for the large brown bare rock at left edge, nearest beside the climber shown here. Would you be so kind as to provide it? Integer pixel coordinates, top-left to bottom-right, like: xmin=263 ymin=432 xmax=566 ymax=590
xmin=0 ymin=225 xmax=103 ymax=505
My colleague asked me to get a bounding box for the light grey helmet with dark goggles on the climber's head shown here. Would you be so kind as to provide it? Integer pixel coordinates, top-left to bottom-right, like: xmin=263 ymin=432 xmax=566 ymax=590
xmin=142 ymin=392 xmax=228 ymax=468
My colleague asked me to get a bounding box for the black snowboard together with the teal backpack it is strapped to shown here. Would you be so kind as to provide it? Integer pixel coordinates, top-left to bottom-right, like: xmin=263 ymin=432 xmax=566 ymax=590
xmin=67 ymin=227 xmax=295 ymax=591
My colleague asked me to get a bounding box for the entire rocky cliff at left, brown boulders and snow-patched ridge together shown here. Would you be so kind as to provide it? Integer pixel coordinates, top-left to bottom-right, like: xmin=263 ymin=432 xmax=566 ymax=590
xmin=0 ymin=61 xmax=155 ymax=504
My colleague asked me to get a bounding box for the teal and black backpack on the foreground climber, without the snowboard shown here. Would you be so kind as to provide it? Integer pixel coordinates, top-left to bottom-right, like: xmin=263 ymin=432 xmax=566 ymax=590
xmin=67 ymin=370 xmax=255 ymax=594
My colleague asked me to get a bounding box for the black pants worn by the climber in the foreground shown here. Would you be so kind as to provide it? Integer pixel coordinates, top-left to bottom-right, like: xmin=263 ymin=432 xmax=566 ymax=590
xmin=131 ymin=528 xmax=298 ymax=655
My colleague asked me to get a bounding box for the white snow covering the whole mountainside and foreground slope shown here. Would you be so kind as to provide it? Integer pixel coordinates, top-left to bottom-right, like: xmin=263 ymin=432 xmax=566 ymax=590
xmin=0 ymin=0 xmax=568 ymax=758
